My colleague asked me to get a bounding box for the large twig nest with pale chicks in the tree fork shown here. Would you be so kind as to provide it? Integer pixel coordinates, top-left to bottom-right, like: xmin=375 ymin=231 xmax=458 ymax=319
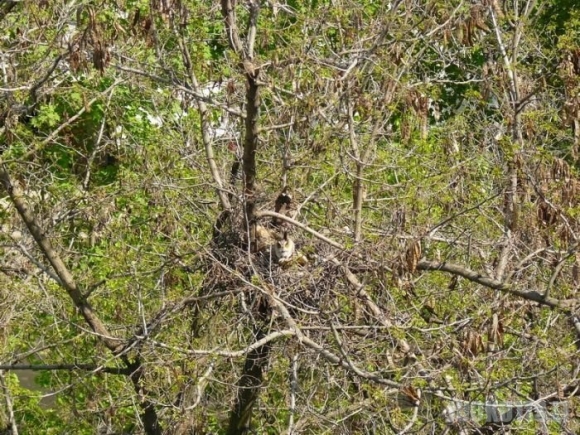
xmin=200 ymin=208 xmax=356 ymax=330
